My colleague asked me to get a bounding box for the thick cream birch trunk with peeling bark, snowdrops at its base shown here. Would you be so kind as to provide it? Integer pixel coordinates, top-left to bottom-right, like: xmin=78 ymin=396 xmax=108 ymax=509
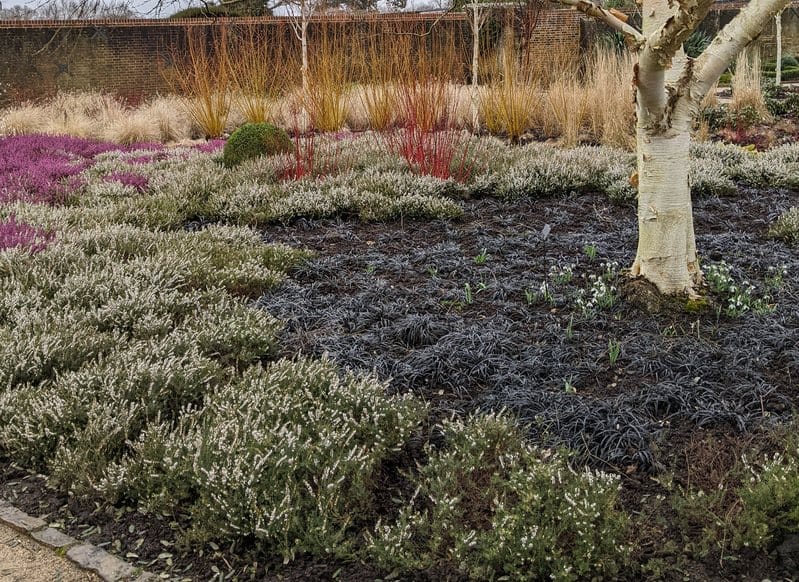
xmin=558 ymin=0 xmax=788 ymax=295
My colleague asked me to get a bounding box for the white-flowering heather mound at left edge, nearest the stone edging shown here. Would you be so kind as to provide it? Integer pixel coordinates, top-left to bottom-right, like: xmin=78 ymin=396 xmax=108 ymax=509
xmin=0 ymin=338 xmax=223 ymax=488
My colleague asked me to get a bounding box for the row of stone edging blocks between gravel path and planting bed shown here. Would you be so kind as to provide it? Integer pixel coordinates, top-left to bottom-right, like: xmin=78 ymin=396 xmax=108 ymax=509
xmin=0 ymin=498 xmax=158 ymax=582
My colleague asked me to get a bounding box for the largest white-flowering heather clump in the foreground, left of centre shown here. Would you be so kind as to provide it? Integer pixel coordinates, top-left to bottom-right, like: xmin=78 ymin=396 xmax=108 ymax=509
xmin=102 ymin=359 xmax=425 ymax=560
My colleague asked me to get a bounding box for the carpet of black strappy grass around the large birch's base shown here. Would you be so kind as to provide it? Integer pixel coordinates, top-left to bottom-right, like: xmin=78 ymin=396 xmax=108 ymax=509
xmin=260 ymin=191 xmax=799 ymax=472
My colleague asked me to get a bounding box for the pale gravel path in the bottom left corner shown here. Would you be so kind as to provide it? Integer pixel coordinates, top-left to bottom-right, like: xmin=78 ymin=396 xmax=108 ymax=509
xmin=0 ymin=524 xmax=100 ymax=582
